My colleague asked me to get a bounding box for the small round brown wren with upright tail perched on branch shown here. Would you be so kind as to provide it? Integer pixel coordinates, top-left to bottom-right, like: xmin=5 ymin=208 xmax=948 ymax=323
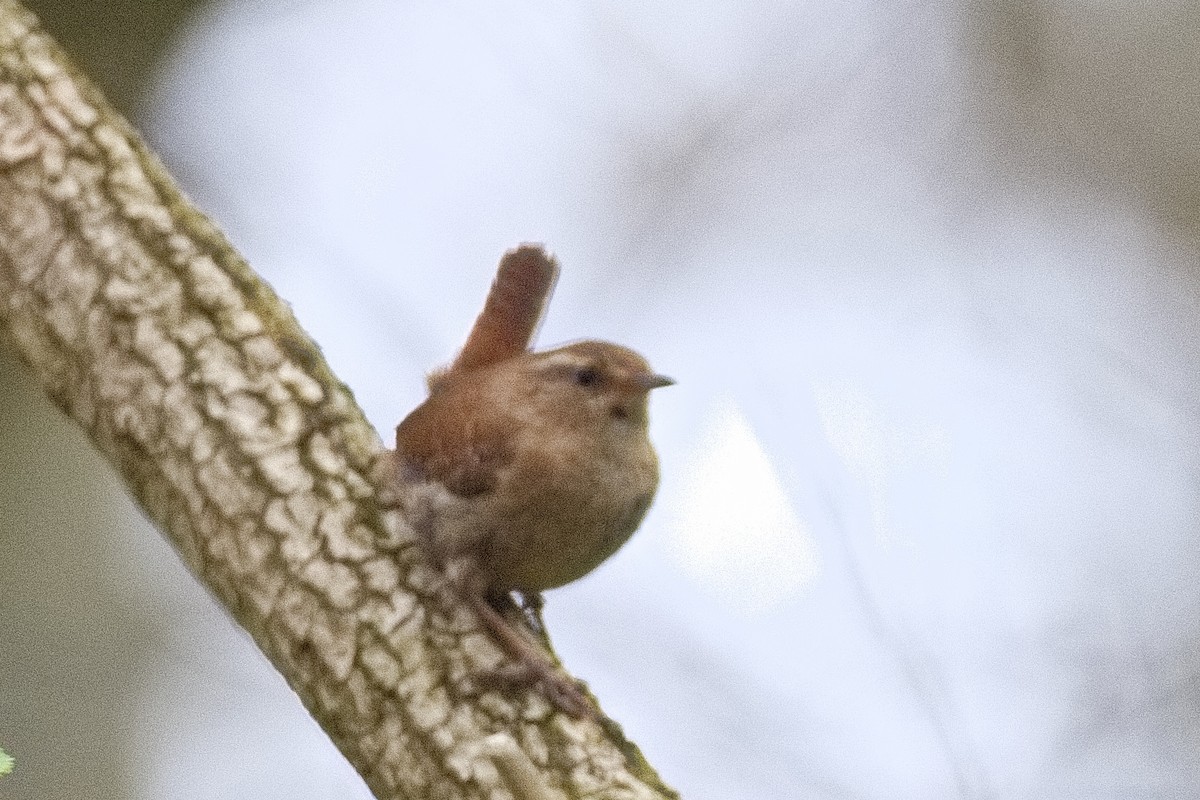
xmin=396 ymin=245 xmax=673 ymax=716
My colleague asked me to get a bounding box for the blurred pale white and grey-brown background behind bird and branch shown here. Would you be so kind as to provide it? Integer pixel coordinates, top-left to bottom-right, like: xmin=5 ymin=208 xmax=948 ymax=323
xmin=0 ymin=0 xmax=1200 ymax=800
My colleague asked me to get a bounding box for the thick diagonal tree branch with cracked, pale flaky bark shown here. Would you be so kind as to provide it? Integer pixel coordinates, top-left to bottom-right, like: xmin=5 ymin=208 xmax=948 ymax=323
xmin=0 ymin=0 xmax=676 ymax=800
